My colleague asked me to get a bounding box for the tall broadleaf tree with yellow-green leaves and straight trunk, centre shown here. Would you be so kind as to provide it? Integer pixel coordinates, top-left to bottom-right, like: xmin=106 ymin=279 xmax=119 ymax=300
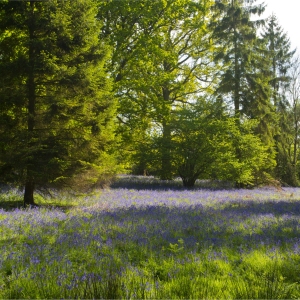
xmin=99 ymin=0 xmax=211 ymax=179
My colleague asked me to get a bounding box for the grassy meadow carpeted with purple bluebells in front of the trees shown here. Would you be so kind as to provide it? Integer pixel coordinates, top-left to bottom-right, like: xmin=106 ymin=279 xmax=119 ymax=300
xmin=0 ymin=177 xmax=300 ymax=299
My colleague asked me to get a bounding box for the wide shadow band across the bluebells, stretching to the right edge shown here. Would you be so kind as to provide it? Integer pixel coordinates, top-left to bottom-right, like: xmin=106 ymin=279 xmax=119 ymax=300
xmin=89 ymin=200 xmax=300 ymax=254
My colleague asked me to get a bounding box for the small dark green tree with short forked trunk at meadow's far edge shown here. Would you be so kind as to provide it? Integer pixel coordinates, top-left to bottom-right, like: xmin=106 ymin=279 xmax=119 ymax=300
xmin=172 ymin=100 xmax=226 ymax=187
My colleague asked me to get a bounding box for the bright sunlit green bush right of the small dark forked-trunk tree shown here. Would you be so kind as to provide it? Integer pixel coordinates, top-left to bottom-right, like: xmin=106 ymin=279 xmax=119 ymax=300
xmin=214 ymin=119 xmax=275 ymax=186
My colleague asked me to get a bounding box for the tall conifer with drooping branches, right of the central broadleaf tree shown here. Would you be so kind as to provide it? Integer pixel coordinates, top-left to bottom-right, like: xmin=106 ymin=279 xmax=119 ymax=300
xmin=211 ymin=0 xmax=277 ymax=180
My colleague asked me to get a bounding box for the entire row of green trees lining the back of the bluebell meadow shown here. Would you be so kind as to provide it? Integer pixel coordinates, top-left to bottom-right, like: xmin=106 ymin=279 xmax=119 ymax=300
xmin=0 ymin=0 xmax=300 ymax=204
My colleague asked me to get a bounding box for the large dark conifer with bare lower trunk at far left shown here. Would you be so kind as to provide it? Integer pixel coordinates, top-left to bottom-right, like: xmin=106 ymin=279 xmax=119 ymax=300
xmin=0 ymin=0 xmax=115 ymax=205
